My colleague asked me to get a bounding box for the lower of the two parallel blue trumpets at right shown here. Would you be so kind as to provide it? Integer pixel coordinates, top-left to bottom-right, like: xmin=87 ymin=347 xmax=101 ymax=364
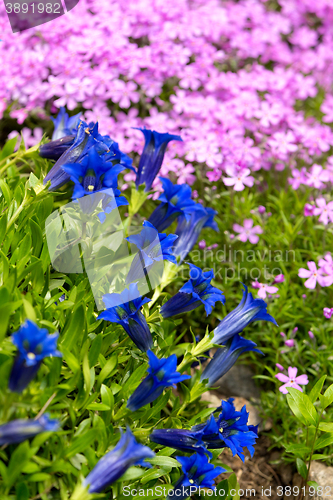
xmin=200 ymin=333 xmax=263 ymax=386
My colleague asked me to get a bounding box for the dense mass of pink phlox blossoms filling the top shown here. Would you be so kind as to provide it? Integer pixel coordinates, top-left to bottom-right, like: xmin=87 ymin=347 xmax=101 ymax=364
xmin=0 ymin=0 xmax=333 ymax=191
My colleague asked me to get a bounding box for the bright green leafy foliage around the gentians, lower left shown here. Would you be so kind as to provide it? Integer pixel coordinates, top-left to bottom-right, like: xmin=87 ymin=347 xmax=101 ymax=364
xmin=0 ymin=140 xmax=234 ymax=500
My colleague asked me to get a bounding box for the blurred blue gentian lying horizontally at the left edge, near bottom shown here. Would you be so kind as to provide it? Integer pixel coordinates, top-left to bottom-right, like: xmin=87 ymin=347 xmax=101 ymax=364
xmin=0 ymin=414 xmax=60 ymax=446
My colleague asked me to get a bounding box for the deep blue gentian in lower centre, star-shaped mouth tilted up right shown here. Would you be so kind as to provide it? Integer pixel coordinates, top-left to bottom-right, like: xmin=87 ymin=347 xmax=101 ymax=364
xmin=127 ymin=351 xmax=191 ymax=411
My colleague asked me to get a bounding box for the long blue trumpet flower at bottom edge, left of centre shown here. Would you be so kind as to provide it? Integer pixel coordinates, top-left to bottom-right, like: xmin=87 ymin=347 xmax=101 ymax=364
xmin=83 ymin=427 xmax=155 ymax=493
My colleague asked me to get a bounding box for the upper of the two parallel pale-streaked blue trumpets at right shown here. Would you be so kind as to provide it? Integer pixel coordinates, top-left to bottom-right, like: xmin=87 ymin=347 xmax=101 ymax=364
xmin=213 ymin=284 xmax=277 ymax=344
